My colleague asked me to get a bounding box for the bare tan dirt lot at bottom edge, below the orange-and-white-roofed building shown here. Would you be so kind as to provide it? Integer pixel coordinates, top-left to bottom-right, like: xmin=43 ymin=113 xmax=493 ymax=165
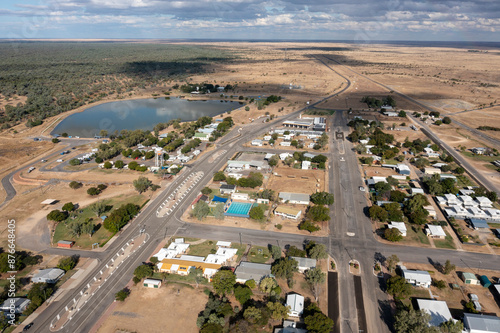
xmin=98 ymin=284 xmax=208 ymax=333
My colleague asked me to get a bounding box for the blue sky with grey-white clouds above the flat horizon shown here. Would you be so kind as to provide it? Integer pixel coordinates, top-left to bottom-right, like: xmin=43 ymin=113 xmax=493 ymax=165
xmin=0 ymin=0 xmax=500 ymax=42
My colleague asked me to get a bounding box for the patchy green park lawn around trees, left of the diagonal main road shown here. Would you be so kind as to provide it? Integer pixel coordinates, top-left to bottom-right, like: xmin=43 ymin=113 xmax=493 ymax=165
xmin=52 ymin=194 xmax=146 ymax=249
